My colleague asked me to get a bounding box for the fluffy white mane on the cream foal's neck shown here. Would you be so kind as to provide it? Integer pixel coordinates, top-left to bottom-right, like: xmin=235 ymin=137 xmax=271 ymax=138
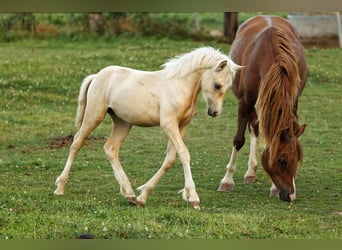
xmin=162 ymin=47 xmax=230 ymax=78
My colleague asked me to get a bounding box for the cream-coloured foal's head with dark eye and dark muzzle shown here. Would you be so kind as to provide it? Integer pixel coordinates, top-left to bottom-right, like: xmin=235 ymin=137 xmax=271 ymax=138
xmin=201 ymin=58 xmax=241 ymax=117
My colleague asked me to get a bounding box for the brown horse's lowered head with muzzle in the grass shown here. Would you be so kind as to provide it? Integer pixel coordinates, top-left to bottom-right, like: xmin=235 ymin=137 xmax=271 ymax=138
xmin=261 ymin=125 xmax=306 ymax=201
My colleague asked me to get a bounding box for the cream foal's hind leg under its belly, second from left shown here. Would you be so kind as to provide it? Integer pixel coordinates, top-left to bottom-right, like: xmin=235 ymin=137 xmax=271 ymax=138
xmin=104 ymin=118 xmax=136 ymax=203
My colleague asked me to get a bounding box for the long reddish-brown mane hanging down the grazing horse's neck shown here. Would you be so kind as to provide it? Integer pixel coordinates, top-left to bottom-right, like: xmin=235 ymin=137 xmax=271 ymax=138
xmin=256 ymin=27 xmax=300 ymax=166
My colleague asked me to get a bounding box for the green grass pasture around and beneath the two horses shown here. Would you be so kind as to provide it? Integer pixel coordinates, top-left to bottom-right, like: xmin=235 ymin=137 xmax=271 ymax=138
xmin=0 ymin=37 xmax=342 ymax=239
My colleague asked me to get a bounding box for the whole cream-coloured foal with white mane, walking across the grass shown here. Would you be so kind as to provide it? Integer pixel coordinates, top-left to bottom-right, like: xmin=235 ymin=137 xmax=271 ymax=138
xmin=55 ymin=47 xmax=240 ymax=209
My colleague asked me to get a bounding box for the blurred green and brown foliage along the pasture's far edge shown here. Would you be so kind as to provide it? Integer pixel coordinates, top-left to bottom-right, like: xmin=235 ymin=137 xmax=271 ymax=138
xmin=0 ymin=12 xmax=276 ymax=41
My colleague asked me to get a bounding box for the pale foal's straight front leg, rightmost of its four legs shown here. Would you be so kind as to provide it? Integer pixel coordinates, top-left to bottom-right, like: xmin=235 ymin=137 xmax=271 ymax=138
xmin=163 ymin=122 xmax=200 ymax=209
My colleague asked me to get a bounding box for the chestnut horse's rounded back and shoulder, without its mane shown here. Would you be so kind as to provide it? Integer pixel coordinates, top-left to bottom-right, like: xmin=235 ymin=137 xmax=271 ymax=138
xmin=229 ymin=16 xmax=306 ymax=99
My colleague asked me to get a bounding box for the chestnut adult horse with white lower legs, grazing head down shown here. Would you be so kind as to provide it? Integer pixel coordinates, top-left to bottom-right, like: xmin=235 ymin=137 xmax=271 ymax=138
xmin=218 ymin=16 xmax=307 ymax=201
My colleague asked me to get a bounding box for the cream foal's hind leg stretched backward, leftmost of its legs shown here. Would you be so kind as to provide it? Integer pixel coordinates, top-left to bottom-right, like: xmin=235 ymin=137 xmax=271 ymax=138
xmin=54 ymin=110 xmax=106 ymax=195
